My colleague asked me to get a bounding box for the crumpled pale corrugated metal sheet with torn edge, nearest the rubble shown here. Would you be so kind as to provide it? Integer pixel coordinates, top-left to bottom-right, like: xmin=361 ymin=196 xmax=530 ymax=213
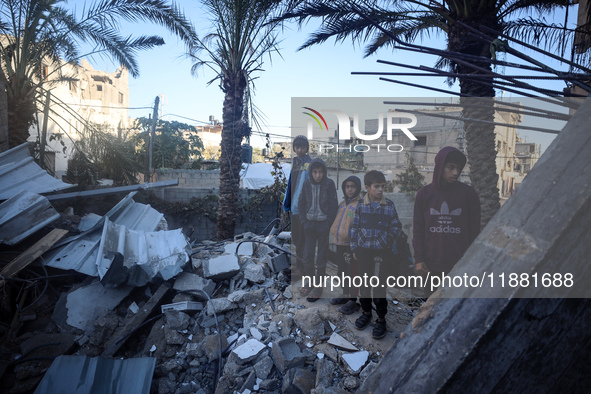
xmin=96 ymin=219 xmax=190 ymax=286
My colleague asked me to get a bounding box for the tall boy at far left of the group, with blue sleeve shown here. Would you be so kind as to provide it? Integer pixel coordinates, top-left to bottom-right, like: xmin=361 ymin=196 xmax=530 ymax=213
xmin=283 ymin=135 xmax=312 ymax=276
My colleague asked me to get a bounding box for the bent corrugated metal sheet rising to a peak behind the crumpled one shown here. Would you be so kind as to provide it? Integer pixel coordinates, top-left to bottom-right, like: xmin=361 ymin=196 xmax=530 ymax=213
xmin=44 ymin=192 xmax=166 ymax=276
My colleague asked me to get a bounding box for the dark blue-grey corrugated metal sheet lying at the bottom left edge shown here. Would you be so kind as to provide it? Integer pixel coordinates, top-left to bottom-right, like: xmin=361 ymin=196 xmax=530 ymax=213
xmin=35 ymin=356 xmax=156 ymax=394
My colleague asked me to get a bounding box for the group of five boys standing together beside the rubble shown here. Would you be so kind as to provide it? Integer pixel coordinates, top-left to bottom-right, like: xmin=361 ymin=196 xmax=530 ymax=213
xmin=284 ymin=136 xmax=480 ymax=339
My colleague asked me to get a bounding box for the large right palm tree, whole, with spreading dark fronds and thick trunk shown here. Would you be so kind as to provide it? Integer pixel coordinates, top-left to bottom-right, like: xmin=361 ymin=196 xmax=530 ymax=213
xmin=279 ymin=0 xmax=584 ymax=226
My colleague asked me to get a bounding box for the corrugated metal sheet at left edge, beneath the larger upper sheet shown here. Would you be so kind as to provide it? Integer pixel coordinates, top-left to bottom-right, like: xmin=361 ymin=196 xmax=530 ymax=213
xmin=0 ymin=190 xmax=60 ymax=245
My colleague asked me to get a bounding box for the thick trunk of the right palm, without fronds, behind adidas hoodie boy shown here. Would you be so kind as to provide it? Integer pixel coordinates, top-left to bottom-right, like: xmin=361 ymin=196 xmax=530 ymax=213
xmin=448 ymin=16 xmax=500 ymax=227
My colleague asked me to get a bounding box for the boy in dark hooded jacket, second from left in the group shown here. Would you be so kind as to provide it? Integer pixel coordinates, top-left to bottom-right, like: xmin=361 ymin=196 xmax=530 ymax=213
xmin=298 ymin=159 xmax=338 ymax=302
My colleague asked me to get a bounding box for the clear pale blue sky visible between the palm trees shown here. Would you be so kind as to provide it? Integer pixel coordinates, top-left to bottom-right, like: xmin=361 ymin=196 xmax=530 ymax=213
xmin=90 ymin=1 xmax=584 ymax=152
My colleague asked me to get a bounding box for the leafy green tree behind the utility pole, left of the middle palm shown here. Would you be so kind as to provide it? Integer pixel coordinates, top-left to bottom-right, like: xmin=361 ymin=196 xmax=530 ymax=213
xmin=134 ymin=117 xmax=203 ymax=169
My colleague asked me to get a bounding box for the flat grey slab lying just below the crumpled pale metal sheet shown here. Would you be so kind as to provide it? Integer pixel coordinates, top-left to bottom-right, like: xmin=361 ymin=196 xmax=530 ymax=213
xmin=52 ymin=281 xmax=133 ymax=331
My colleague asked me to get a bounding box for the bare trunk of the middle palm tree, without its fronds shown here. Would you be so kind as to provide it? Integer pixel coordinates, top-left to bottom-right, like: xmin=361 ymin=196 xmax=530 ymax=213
xmin=216 ymin=73 xmax=246 ymax=241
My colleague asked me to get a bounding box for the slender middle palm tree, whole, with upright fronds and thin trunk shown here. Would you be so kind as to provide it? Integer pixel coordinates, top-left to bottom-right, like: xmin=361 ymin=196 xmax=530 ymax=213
xmin=189 ymin=0 xmax=280 ymax=240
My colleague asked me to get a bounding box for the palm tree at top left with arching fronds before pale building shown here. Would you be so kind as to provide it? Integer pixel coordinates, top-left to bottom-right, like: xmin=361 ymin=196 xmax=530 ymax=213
xmin=0 ymin=0 xmax=197 ymax=146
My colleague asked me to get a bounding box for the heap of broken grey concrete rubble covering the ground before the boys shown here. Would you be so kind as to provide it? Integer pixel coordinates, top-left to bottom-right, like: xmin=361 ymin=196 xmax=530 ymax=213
xmin=1 ymin=212 xmax=418 ymax=394
